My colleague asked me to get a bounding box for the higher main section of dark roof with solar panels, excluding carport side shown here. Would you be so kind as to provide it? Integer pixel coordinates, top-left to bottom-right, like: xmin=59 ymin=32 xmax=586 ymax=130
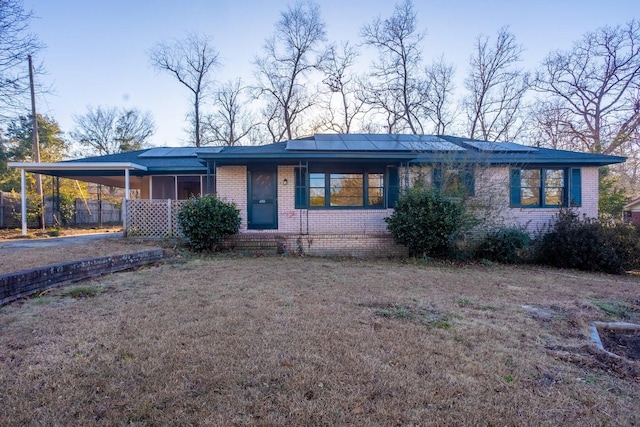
xmin=198 ymin=134 xmax=626 ymax=166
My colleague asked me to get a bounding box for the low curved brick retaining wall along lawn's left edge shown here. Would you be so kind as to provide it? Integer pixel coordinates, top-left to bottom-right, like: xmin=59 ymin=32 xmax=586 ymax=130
xmin=0 ymin=249 xmax=166 ymax=305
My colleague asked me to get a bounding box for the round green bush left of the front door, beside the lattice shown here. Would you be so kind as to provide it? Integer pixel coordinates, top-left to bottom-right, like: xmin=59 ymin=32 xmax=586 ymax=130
xmin=178 ymin=195 xmax=240 ymax=252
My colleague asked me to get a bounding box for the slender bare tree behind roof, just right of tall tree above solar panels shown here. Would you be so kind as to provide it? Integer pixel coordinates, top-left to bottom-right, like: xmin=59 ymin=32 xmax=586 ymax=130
xmin=424 ymin=56 xmax=455 ymax=135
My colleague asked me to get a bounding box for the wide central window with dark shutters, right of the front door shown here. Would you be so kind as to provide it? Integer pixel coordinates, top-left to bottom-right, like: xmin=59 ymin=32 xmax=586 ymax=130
xmin=294 ymin=168 xmax=398 ymax=209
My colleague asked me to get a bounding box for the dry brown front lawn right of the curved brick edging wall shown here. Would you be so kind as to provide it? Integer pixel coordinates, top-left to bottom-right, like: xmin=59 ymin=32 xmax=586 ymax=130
xmin=0 ymin=256 xmax=640 ymax=426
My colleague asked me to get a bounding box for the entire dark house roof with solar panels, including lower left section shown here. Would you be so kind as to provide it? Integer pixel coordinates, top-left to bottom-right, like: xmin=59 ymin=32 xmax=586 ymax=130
xmin=38 ymin=134 xmax=626 ymax=175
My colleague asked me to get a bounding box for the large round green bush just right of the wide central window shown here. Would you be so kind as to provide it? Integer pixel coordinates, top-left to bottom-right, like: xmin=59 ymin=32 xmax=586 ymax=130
xmin=385 ymin=186 xmax=464 ymax=256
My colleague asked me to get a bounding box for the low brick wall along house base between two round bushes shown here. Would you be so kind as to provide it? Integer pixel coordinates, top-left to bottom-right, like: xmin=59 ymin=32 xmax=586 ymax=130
xmin=222 ymin=233 xmax=407 ymax=258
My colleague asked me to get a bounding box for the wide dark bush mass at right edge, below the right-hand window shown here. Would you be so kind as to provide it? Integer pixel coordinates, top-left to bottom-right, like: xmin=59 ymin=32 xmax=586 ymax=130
xmin=536 ymin=210 xmax=640 ymax=274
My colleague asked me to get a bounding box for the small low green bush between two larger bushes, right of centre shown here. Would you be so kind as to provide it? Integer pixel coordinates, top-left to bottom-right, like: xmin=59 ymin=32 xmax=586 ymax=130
xmin=476 ymin=228 xmax=531 ymax=264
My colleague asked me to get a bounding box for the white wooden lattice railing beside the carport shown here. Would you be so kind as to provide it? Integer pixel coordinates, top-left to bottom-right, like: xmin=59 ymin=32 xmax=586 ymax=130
xmin=125 ymin=199 xmax=185 ymax=237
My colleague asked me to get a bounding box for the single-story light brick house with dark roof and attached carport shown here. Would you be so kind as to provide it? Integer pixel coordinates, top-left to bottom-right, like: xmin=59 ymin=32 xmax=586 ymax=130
xmin=11 ymin=134 xmax=625 ymax=254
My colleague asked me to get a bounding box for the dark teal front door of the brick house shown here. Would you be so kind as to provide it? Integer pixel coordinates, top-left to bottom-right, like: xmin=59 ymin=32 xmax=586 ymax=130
xmin=247 ymin=170 xmax=278 ymax=230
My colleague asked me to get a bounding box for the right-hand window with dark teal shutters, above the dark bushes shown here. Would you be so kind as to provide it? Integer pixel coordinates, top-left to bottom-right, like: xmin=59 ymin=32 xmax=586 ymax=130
xmin=510 ymin=168 xmax=582 ymax=208
